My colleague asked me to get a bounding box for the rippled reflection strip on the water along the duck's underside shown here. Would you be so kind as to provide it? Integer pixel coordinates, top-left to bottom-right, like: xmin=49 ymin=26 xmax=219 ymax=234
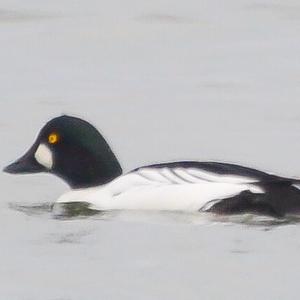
xmin=9 ymin=202 xmax=300 ymax=227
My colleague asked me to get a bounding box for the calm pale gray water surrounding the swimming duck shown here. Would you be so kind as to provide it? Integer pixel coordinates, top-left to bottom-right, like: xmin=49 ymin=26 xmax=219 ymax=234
xmin=0 ymin=0 xmax=300 ymax=300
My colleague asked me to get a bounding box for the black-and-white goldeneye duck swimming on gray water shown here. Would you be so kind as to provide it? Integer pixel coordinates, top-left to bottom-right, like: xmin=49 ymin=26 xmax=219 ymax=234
xmin=3 ymin=115 xmax=300 ymax=218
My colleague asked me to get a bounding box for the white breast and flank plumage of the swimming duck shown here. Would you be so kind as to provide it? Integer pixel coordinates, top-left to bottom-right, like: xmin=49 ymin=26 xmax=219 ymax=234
xmin=57 ymin=168 xmax=264 ymax=211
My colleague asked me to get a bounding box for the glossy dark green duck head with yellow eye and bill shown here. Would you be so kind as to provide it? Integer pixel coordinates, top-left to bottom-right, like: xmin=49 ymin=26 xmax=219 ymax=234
xmin=4 ymin=115 xmax=122 ymax=188
